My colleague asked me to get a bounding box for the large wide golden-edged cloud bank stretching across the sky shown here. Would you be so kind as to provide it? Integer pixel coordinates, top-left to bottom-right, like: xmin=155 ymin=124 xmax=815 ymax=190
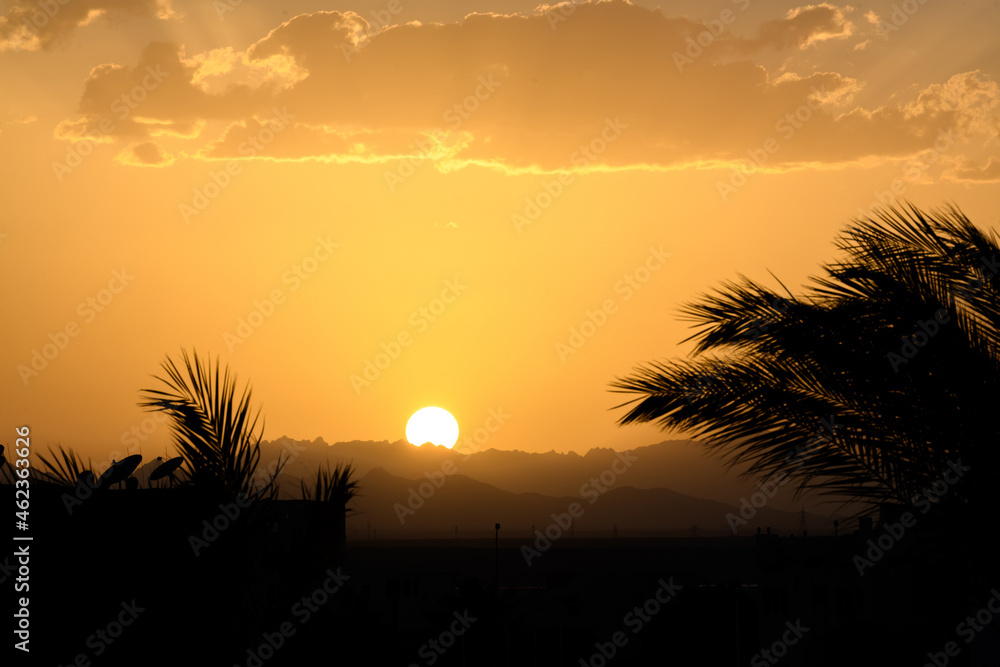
xmin=57 ymin=1 xmax=1000 ymax=172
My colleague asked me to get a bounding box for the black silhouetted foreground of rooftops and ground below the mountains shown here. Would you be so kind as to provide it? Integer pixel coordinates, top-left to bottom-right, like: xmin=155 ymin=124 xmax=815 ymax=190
xmin=2 ymin=487 xmax=1000 ymax=667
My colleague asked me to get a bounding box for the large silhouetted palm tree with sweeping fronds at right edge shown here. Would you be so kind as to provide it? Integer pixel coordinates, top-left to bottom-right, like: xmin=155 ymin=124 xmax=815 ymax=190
xmin=612 ymin=204 xmax=1000 ymax=530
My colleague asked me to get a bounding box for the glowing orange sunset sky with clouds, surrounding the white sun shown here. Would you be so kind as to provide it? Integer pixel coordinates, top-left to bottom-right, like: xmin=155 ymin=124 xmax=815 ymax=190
xmin=0 ymin=0 xmax=1000 ymax=460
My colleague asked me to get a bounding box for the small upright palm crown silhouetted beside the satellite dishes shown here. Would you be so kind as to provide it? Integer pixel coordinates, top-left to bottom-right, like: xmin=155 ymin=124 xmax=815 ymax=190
xmin=139 ymin=349 xmax=284 ymax=499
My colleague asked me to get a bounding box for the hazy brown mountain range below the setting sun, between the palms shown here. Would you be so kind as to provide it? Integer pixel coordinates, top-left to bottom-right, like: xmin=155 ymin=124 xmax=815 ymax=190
xmin=242 ymin=437 xmax=844 ymax=537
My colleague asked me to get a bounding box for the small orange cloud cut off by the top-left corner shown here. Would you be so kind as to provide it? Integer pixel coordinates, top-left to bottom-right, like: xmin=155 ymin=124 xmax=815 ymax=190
xmin=0 ymin=0 xmax=175 ymax=52
